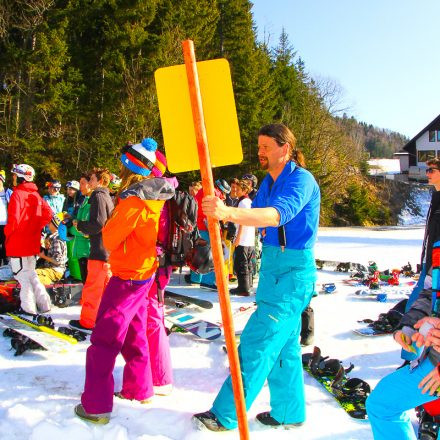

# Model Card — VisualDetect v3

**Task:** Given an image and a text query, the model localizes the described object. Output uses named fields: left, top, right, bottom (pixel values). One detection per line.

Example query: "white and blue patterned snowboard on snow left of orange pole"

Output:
left=165, top=307, right=222, bottom=341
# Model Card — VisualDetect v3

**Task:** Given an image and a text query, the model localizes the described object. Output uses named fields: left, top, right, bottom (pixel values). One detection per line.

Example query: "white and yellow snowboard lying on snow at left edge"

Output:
left=0, top=315, right=76, bottom=354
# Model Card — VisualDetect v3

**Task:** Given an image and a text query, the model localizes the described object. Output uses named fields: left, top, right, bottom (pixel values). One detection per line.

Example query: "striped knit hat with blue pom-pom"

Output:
left=121, top=138, right=166, bottom=177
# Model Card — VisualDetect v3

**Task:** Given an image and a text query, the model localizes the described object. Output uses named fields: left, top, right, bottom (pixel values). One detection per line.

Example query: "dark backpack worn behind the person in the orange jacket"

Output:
left=159, top=191, right=199, bottom=268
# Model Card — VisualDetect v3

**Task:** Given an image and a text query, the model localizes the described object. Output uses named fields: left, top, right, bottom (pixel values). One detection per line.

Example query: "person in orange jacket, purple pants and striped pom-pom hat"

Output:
left=75, top=138, right=174, bottom=424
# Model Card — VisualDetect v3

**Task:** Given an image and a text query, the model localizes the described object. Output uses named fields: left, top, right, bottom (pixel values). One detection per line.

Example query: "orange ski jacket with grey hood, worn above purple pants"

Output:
left=102, top=178, right=174, bottom=280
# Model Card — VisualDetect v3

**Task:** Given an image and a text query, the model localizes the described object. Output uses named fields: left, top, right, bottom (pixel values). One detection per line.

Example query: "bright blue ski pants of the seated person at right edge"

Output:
left=366, top=358, right=438, bottom=440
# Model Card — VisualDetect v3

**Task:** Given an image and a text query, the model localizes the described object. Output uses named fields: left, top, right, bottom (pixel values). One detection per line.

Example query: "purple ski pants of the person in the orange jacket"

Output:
left=81, top=276, right=154, bottom=414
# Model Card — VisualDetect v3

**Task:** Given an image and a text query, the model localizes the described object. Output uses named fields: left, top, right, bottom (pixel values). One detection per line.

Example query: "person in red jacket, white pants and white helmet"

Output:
left=5, top=164, right=53, bottom=314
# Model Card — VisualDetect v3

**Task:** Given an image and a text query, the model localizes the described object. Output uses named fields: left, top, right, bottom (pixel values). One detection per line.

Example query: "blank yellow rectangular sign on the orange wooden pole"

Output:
left=154, top=58, right=243, bottom=173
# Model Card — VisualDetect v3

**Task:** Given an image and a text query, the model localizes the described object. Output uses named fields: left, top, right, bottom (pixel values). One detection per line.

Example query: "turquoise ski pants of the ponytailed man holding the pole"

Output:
left=211, top=246, right=316, bottom=429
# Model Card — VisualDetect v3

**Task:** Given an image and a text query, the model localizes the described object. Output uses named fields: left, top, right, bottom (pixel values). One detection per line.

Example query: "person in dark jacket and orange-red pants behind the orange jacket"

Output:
left=69, top=168, right=113, bottom=333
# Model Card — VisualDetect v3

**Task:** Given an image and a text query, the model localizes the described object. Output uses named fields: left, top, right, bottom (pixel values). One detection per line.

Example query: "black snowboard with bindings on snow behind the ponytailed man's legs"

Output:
left=302, top=347, right=370, bottom=419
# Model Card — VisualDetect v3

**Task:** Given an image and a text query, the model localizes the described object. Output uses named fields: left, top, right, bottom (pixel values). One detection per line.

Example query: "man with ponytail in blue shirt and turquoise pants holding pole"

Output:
left=194, top=124, right=320, bottom=431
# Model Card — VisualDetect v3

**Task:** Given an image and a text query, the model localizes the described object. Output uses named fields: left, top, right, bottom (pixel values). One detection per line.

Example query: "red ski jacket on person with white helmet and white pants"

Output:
left=5, top=182, right=53, bottom=257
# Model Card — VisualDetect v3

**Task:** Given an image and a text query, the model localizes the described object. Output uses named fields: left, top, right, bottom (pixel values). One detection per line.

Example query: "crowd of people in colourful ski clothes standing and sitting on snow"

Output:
left=5, top=124, right=440, bottom=439
